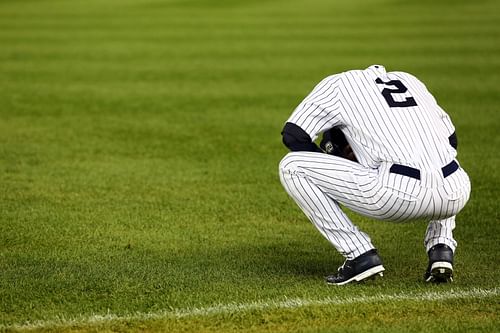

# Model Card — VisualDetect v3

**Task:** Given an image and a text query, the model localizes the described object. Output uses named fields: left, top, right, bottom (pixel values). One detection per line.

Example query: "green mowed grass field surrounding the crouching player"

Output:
left=0, top=0, right=500, bottom=332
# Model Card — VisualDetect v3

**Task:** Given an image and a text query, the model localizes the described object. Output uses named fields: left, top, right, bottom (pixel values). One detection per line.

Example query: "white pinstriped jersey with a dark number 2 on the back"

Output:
left=288, top=65, right=456, bottom=170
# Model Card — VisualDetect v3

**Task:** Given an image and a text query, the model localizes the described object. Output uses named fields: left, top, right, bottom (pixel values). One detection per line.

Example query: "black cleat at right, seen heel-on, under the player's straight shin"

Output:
left=424, top=244, right=453, bottom=283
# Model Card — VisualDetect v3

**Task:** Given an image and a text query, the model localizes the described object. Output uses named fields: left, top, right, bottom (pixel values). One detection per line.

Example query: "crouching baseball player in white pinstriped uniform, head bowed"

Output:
left=279, top=65, right=470, bottom=285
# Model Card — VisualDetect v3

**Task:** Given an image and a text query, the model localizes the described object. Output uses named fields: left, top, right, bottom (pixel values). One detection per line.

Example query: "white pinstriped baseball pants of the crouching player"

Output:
left=279, top=152, right=470, bottom=259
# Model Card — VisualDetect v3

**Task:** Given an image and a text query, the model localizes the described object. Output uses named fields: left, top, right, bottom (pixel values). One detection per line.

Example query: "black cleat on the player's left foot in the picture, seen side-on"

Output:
left=326, top=249, right=385, bottom=286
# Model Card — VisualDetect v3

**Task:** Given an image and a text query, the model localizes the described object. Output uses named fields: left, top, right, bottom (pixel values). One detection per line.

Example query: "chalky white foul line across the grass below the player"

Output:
left=0, top=288, right=500, bottom=330
